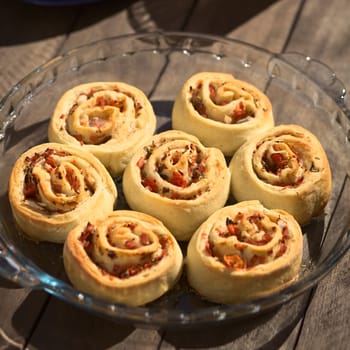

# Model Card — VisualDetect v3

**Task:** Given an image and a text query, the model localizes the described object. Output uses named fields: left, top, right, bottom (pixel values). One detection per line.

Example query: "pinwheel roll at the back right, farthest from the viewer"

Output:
left=172, top=72, right=274, bottom=156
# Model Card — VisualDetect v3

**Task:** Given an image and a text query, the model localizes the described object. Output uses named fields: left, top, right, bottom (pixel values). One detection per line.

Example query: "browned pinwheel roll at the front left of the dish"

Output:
left=63, top=210, right=183, bottom=306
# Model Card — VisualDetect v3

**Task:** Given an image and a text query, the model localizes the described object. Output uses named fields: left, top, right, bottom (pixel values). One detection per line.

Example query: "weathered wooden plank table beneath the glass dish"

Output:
left=0, top=0, right=350, bottom=350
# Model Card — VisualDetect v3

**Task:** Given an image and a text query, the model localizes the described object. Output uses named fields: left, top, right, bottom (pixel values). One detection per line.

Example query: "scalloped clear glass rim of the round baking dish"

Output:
left=0, top=31, right=350, bottom=326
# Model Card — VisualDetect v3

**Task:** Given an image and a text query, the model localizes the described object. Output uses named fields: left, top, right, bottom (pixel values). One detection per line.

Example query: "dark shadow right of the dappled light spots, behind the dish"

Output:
left=128, top=0, right=276, bottom=35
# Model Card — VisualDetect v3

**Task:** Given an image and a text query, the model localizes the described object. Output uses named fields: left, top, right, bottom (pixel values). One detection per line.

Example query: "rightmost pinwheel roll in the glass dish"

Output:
left=229, top=125, right=332, bottom=225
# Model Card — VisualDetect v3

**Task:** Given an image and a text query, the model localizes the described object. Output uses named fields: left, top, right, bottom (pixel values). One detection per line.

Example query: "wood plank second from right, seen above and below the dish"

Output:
left=154, top=1, right=309, bottom=350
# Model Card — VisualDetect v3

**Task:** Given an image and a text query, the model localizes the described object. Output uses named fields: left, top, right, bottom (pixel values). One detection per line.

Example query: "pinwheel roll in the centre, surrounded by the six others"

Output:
left=123, top=130, right=230, bottom=240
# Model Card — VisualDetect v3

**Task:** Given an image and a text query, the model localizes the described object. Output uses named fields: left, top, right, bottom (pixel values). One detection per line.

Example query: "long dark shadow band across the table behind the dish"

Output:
left=0, top=0, right=277, bottom=46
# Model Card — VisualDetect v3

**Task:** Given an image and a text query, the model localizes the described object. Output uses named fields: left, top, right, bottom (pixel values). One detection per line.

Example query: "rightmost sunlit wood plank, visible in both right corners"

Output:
left=286, top=0, right=350, bottom=349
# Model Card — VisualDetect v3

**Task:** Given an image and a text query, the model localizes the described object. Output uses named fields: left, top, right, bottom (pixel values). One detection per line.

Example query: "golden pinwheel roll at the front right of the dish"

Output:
left=186, top=201, right=303, bottom=304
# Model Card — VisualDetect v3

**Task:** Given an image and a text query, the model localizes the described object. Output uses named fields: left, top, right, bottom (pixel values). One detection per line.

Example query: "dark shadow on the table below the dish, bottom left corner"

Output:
left=12, top=291, right=135, bottom=350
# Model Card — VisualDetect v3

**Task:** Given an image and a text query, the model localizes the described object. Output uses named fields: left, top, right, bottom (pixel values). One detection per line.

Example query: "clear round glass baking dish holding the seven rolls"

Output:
left=0, top=33, right=350, bottom=326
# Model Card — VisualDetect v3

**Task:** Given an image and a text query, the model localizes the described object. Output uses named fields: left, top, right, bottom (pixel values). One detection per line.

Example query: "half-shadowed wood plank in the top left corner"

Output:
left=0, top=1, right=79, bottom=97
